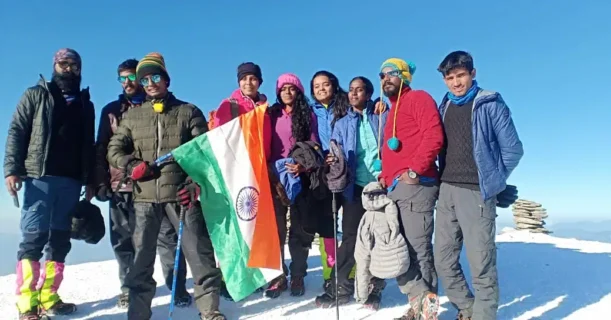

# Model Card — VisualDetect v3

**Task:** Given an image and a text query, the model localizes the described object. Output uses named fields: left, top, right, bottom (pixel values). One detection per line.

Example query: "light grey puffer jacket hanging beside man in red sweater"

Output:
left=354, top=182, right=410, bottom=303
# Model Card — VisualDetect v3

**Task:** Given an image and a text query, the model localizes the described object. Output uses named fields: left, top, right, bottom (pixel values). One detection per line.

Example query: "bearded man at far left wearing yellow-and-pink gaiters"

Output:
left=4, top=49, right=95, bottom=320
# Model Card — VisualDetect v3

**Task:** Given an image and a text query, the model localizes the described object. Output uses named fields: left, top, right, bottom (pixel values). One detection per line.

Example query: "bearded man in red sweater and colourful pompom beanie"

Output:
left=380, top=58, right=443, bottom=320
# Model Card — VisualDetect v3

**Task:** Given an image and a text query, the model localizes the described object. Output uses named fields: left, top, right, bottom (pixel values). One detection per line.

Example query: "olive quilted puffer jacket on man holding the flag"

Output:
left=107, top=93, right=208, bottom=203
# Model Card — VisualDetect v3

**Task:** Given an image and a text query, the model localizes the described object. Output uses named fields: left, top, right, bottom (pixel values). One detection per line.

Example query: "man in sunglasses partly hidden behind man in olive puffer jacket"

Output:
left=95, top=59, right=191, bottom=308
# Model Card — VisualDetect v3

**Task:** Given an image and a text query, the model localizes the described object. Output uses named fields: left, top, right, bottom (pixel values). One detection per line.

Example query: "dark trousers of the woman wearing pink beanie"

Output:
left=274, top=197, right=314, bottom=277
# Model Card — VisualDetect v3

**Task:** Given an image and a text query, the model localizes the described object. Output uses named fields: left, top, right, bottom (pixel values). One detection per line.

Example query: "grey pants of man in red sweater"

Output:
left=388, top=183, right=439, bottom=298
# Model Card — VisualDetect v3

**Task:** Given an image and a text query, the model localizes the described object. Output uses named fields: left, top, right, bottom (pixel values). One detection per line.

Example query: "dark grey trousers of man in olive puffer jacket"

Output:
left=125, top=202, right=221, bottom=320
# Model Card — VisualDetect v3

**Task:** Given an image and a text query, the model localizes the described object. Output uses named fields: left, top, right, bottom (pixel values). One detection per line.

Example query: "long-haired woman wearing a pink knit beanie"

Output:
left=265, top=73, right=320, bottom=298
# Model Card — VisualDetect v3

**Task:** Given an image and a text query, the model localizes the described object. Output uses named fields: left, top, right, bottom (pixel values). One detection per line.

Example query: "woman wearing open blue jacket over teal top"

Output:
left=316, top=77, right=388, bottom=309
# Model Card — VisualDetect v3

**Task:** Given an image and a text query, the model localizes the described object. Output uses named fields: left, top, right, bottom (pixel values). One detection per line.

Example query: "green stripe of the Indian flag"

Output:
left=172, top=134, right=267, bottom=301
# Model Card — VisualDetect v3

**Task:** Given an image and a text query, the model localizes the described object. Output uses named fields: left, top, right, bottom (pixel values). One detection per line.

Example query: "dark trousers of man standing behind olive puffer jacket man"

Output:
left=108, top=192, right=187, bottom=294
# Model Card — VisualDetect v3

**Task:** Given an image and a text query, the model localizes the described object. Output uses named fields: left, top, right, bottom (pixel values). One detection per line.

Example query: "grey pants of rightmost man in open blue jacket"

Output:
left=435, top=183, right=499, bottom=320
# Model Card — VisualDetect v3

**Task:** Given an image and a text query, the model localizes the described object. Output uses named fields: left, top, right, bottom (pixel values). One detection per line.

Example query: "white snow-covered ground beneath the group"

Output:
left=0, top=229, right=611, bottom=320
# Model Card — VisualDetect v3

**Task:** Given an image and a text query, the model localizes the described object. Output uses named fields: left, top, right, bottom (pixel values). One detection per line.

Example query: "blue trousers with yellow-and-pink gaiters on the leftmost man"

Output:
left=16, top=176, right=81, bottom=313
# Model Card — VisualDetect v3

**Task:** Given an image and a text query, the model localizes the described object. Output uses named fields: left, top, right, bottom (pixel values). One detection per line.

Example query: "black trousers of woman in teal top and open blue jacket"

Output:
left=329, top=185, right=365, bottom=295
